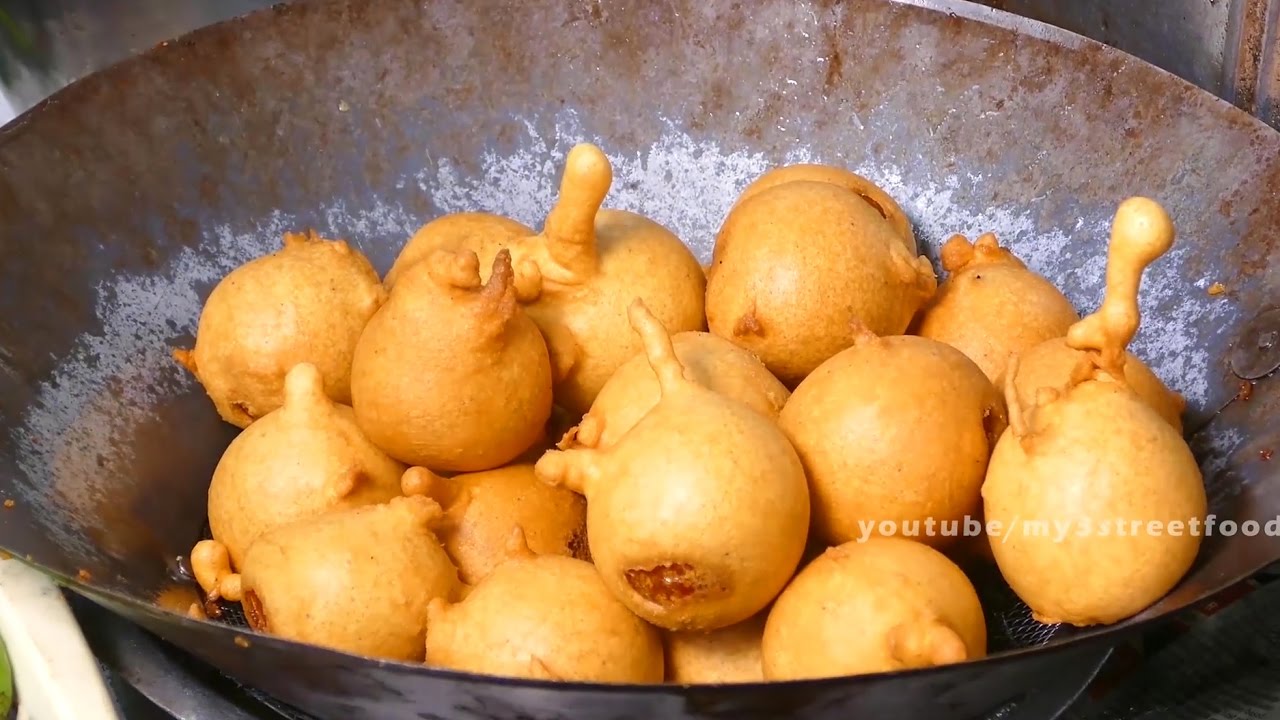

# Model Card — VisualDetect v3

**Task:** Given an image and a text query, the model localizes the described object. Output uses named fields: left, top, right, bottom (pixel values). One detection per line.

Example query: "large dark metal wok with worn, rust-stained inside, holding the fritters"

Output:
left=0, top=0, right=1280, bottom=720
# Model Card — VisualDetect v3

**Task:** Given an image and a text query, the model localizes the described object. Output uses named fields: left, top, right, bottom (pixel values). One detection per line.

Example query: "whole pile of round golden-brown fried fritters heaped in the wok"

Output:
left=174, top=145, right=1206, bottom=683
